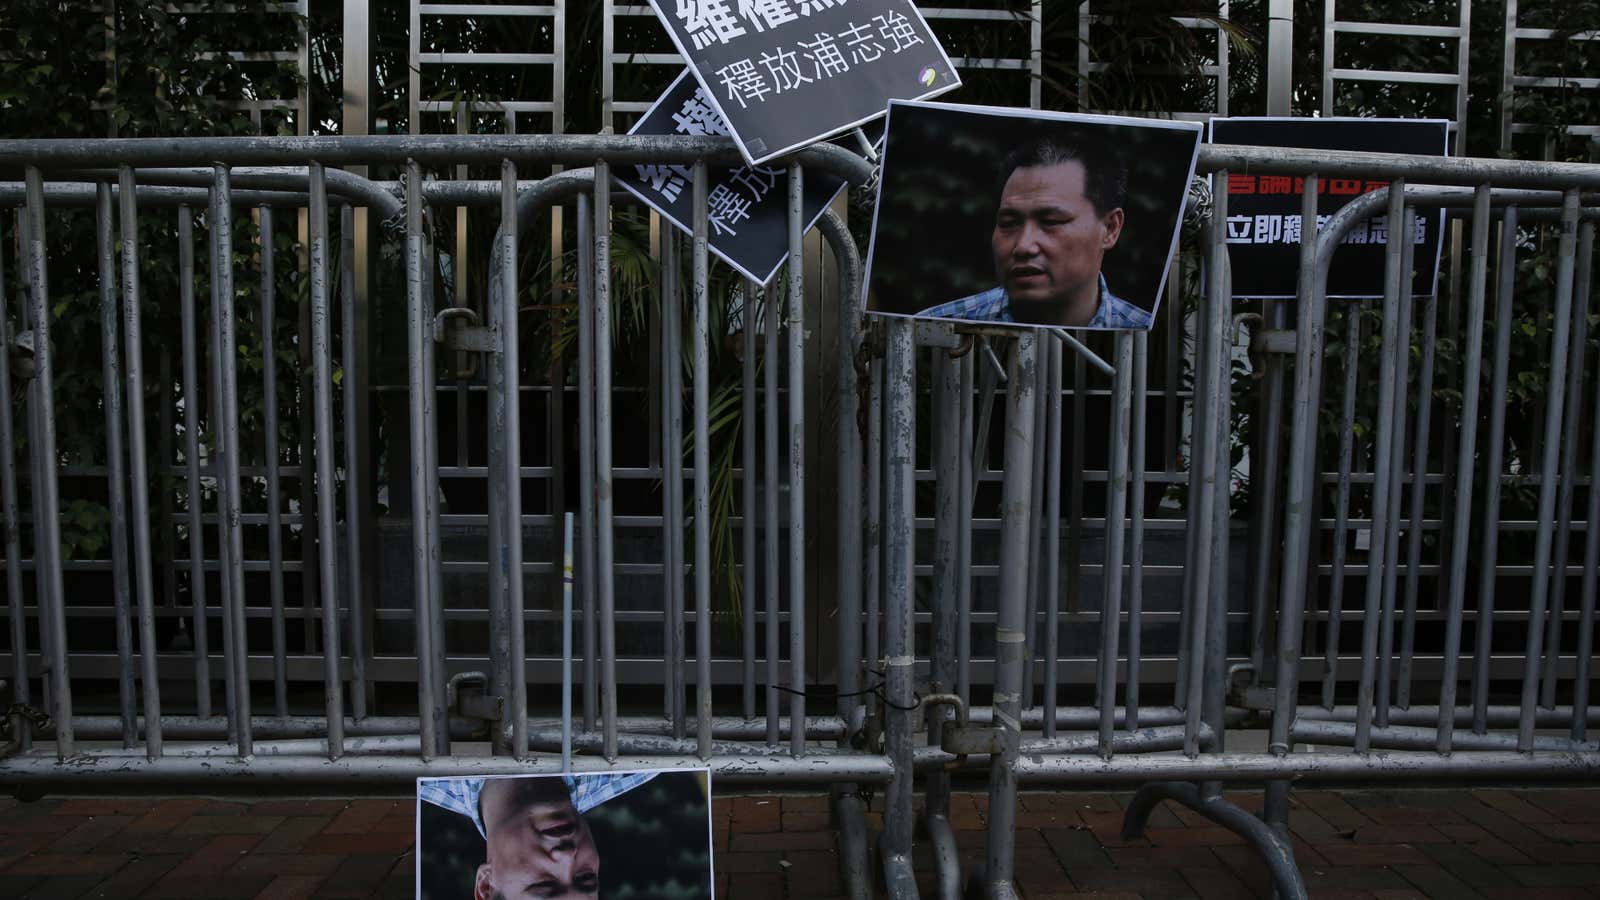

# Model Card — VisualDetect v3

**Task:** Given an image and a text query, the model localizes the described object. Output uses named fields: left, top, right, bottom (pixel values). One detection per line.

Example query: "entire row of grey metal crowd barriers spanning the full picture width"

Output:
left=0, top=136, right=1600, bottom=897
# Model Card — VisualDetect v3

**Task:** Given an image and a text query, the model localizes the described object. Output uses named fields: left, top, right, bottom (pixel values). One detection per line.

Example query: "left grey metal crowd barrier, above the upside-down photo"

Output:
left=0, top=136, right=915, bottom=897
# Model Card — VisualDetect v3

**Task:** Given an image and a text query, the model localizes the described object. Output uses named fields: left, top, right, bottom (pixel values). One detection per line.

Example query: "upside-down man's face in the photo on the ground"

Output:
left=472, top=778, right=600, bottom=900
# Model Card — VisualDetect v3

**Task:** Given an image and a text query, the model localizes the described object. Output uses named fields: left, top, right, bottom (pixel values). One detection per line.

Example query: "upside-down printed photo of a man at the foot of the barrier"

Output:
left=416, top=769, right=714, bottom=900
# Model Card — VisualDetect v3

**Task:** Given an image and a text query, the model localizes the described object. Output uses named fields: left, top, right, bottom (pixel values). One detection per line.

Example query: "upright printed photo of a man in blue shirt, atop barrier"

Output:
left=866, top=102, right=1202, bottom=330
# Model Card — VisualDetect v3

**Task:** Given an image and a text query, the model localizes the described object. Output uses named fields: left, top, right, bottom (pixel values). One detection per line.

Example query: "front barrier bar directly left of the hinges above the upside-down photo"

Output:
left=405, top=160, right=440, bottom=759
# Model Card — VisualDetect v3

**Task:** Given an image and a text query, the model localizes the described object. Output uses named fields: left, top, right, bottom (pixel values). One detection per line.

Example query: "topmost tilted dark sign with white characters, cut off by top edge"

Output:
left=650, top=0, right=962, bottom=163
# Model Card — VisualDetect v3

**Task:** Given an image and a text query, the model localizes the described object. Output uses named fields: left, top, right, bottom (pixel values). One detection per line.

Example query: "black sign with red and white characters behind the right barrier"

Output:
left=1211, top=119, right=1450, bottom=298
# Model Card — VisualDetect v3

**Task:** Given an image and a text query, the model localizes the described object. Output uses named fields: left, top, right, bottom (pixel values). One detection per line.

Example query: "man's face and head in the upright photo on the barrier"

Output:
left=992, top=160, right=1123, bottom=325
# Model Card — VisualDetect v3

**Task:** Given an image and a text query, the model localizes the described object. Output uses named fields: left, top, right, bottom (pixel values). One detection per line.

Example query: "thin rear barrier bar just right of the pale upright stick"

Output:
left=578, top=194, right=600, bottom=732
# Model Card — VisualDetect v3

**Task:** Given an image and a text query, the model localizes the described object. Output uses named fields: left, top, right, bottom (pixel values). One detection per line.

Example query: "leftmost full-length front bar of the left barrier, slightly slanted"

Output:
left=24, top=167, right=75, bottom=759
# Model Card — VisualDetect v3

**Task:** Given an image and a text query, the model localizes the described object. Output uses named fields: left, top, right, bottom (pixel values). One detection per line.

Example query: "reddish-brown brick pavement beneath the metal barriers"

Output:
left=0, top=788, right=1600, bottom=900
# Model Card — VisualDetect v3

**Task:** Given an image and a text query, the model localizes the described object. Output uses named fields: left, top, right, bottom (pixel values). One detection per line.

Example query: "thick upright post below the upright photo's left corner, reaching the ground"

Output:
left=883, top=315, right=917, bottom=890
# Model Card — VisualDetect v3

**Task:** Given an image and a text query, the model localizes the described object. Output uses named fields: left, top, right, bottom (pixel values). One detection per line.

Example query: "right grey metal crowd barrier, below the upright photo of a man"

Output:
left=902, top=146, right=1600, bottom=898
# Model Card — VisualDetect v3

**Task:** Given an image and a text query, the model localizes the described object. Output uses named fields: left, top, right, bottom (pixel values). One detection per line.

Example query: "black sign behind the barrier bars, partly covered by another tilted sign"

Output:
left=613, top=70, right=845, bottom=285
